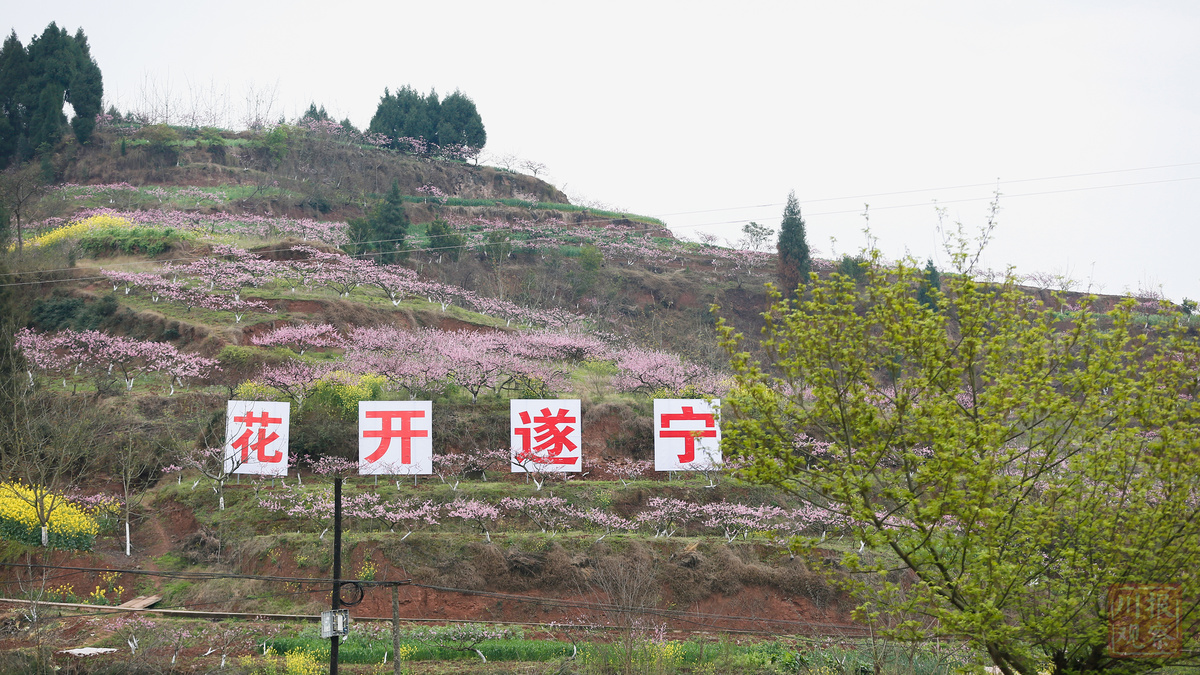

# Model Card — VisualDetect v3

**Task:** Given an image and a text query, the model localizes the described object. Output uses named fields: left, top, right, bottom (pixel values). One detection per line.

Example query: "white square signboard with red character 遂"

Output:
left=509, top=399, right=583, bottom=473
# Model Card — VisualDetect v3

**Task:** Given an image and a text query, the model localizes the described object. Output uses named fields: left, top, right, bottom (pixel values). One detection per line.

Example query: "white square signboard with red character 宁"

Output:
left=654, top=399, right=721, bottom=471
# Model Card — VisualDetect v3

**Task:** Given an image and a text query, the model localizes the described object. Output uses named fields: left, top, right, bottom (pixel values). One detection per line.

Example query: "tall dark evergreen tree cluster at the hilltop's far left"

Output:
left=0, top=23, right=104, bottom=166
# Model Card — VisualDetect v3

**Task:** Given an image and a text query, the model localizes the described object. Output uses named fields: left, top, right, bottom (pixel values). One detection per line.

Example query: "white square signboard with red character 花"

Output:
left=224, top=401, right=292, bottom=476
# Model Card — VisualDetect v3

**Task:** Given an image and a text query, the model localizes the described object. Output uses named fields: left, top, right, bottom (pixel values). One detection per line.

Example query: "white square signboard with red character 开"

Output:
left=359, top=401, right=433, bottom=476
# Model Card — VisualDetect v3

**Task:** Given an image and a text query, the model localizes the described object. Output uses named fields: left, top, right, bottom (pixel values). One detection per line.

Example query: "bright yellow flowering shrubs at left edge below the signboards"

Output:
left=0, top=483, right=100, bottom=550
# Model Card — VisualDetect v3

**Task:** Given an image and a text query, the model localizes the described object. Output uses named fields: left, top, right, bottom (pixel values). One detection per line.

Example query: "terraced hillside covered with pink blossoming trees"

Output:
left=0, top=127, right=1194, bottom=673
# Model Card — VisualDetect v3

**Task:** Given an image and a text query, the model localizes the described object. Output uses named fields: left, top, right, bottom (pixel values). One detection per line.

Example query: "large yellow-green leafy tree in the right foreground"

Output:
left=720, top=246, right=1200, bottom=675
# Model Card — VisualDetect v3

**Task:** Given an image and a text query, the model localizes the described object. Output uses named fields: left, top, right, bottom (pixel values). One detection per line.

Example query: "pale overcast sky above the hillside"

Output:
left=4, top=0, right=1200, bottom=301
